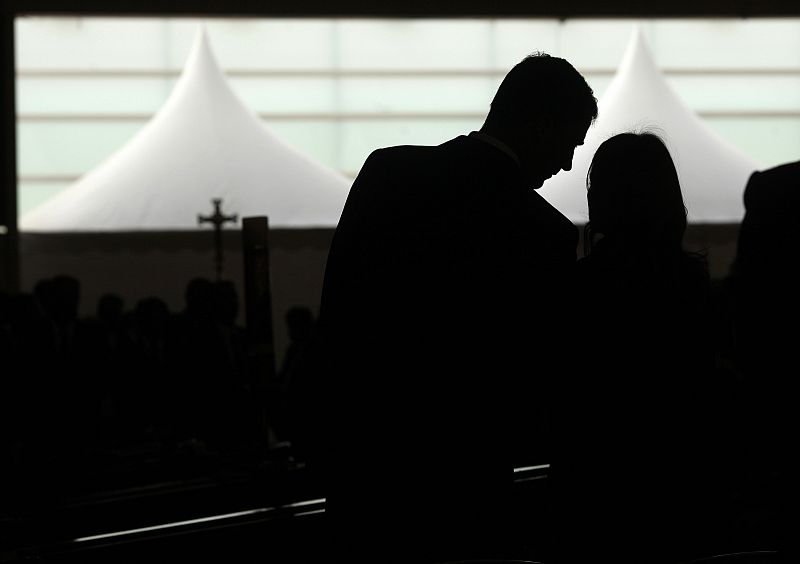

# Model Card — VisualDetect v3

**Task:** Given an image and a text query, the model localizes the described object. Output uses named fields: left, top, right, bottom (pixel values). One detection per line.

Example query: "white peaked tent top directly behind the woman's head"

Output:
left=540, top=27, right=759, bottom=224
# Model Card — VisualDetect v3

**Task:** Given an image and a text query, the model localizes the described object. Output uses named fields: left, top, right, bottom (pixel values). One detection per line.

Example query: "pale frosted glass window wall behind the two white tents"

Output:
left=16, top=17, right=800, bottom=217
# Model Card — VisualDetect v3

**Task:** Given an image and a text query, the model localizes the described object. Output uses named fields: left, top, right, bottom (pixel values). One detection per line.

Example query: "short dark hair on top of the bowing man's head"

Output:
left=487, top=52, right=597, bottom=126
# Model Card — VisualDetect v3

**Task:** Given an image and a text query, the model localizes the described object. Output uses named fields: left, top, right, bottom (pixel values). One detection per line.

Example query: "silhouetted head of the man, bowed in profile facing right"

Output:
left=481, top=53, right=597, bottom=188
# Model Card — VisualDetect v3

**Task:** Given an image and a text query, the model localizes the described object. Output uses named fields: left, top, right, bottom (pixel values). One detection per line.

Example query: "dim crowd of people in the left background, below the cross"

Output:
left=0, top=275, right=269, bottom=503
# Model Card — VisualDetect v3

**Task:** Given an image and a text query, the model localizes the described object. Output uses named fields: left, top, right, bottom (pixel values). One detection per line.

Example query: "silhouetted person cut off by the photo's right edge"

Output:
left=729, top=161, right=800, bottom=561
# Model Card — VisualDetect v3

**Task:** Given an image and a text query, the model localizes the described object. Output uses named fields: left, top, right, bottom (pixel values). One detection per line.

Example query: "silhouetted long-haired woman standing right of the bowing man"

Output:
left=552, top=133, right=714, bottom=562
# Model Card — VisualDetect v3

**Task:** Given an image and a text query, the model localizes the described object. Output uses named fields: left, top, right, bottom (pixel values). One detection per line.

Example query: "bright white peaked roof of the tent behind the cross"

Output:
left=20, top=29, right=350, bottom=232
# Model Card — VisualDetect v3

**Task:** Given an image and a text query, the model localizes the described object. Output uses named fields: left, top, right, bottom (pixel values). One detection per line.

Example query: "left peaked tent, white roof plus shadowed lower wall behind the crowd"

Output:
left=20, top=30, right=350, bottom=358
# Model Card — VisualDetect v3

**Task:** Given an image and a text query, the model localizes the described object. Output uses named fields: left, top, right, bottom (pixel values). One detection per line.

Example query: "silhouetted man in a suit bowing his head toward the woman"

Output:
left=320, top=54, right=597, bottom=562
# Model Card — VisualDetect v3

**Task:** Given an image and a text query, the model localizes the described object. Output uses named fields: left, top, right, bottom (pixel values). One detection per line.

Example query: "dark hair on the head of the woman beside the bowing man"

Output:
left=585, top=132, right=687, bottom=254
